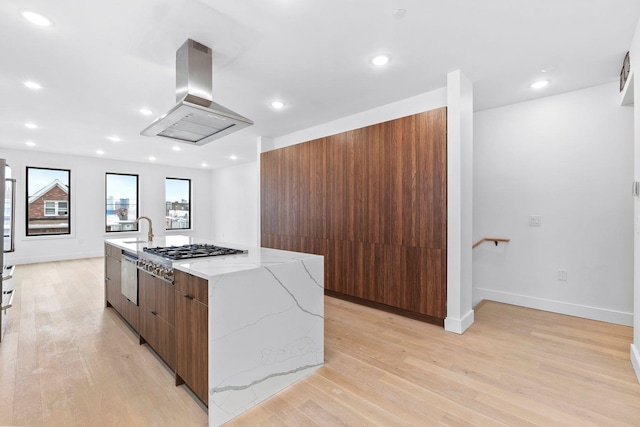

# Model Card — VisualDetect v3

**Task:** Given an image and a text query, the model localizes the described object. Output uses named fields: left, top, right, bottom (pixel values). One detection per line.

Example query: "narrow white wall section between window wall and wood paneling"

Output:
left=210, top=162, right=260, bottom=246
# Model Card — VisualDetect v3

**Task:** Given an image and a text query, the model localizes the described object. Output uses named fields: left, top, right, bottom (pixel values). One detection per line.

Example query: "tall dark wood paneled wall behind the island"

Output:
left=261, top=108, right=447, bottom=321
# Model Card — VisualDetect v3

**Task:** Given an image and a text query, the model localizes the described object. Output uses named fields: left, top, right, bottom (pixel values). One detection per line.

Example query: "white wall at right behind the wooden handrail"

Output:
left=473, top=83, right=633, bottom=325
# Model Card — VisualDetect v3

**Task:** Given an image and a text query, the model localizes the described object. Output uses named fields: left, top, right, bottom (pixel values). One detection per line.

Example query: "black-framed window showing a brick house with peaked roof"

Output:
left=26, top=167, right=71, bottom=236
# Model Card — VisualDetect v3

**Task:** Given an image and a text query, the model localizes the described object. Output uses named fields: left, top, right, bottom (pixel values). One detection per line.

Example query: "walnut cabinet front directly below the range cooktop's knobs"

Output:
left=138, top=271, right=176, bottom=371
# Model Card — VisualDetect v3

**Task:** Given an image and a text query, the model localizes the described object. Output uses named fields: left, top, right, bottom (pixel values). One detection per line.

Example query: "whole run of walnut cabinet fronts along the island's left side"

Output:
left=105, top=244, right=209, bottom=405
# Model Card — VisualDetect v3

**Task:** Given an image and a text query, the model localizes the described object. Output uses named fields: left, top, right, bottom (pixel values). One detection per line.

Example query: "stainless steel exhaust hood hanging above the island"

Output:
left=140, top=39, right=253, bottom=145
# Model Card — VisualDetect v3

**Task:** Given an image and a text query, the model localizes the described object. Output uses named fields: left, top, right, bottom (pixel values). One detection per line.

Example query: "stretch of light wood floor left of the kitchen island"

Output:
left=0, top=258, right=208, bottom=426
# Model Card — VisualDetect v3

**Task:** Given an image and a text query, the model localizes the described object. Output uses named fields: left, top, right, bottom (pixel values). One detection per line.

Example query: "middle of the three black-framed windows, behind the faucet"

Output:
left=105, top=172, right=138, bottom=232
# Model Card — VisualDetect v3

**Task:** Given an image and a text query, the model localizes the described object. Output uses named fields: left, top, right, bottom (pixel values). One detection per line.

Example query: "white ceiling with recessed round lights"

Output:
left=0, top=0, right=640, bottom=168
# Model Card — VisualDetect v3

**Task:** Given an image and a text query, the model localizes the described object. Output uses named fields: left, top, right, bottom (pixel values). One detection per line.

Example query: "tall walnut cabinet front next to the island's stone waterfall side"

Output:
left=175, top=271, right=209, bottom=405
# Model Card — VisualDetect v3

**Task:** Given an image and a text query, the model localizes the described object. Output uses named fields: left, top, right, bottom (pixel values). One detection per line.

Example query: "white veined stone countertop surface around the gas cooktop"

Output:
left=105, top=235, right=322, bottom=280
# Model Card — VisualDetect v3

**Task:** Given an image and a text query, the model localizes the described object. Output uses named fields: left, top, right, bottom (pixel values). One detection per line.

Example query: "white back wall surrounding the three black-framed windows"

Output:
left=0, top=149, right=211, bottom=264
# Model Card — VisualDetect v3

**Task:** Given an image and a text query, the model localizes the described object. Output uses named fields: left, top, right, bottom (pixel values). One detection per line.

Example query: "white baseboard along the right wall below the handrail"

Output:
left=474, top=288, right=633, bottom=326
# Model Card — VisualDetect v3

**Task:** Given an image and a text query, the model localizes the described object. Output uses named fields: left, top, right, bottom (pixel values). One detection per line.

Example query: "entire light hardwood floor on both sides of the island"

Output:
left=0, top=258, right=640, bottom=426
